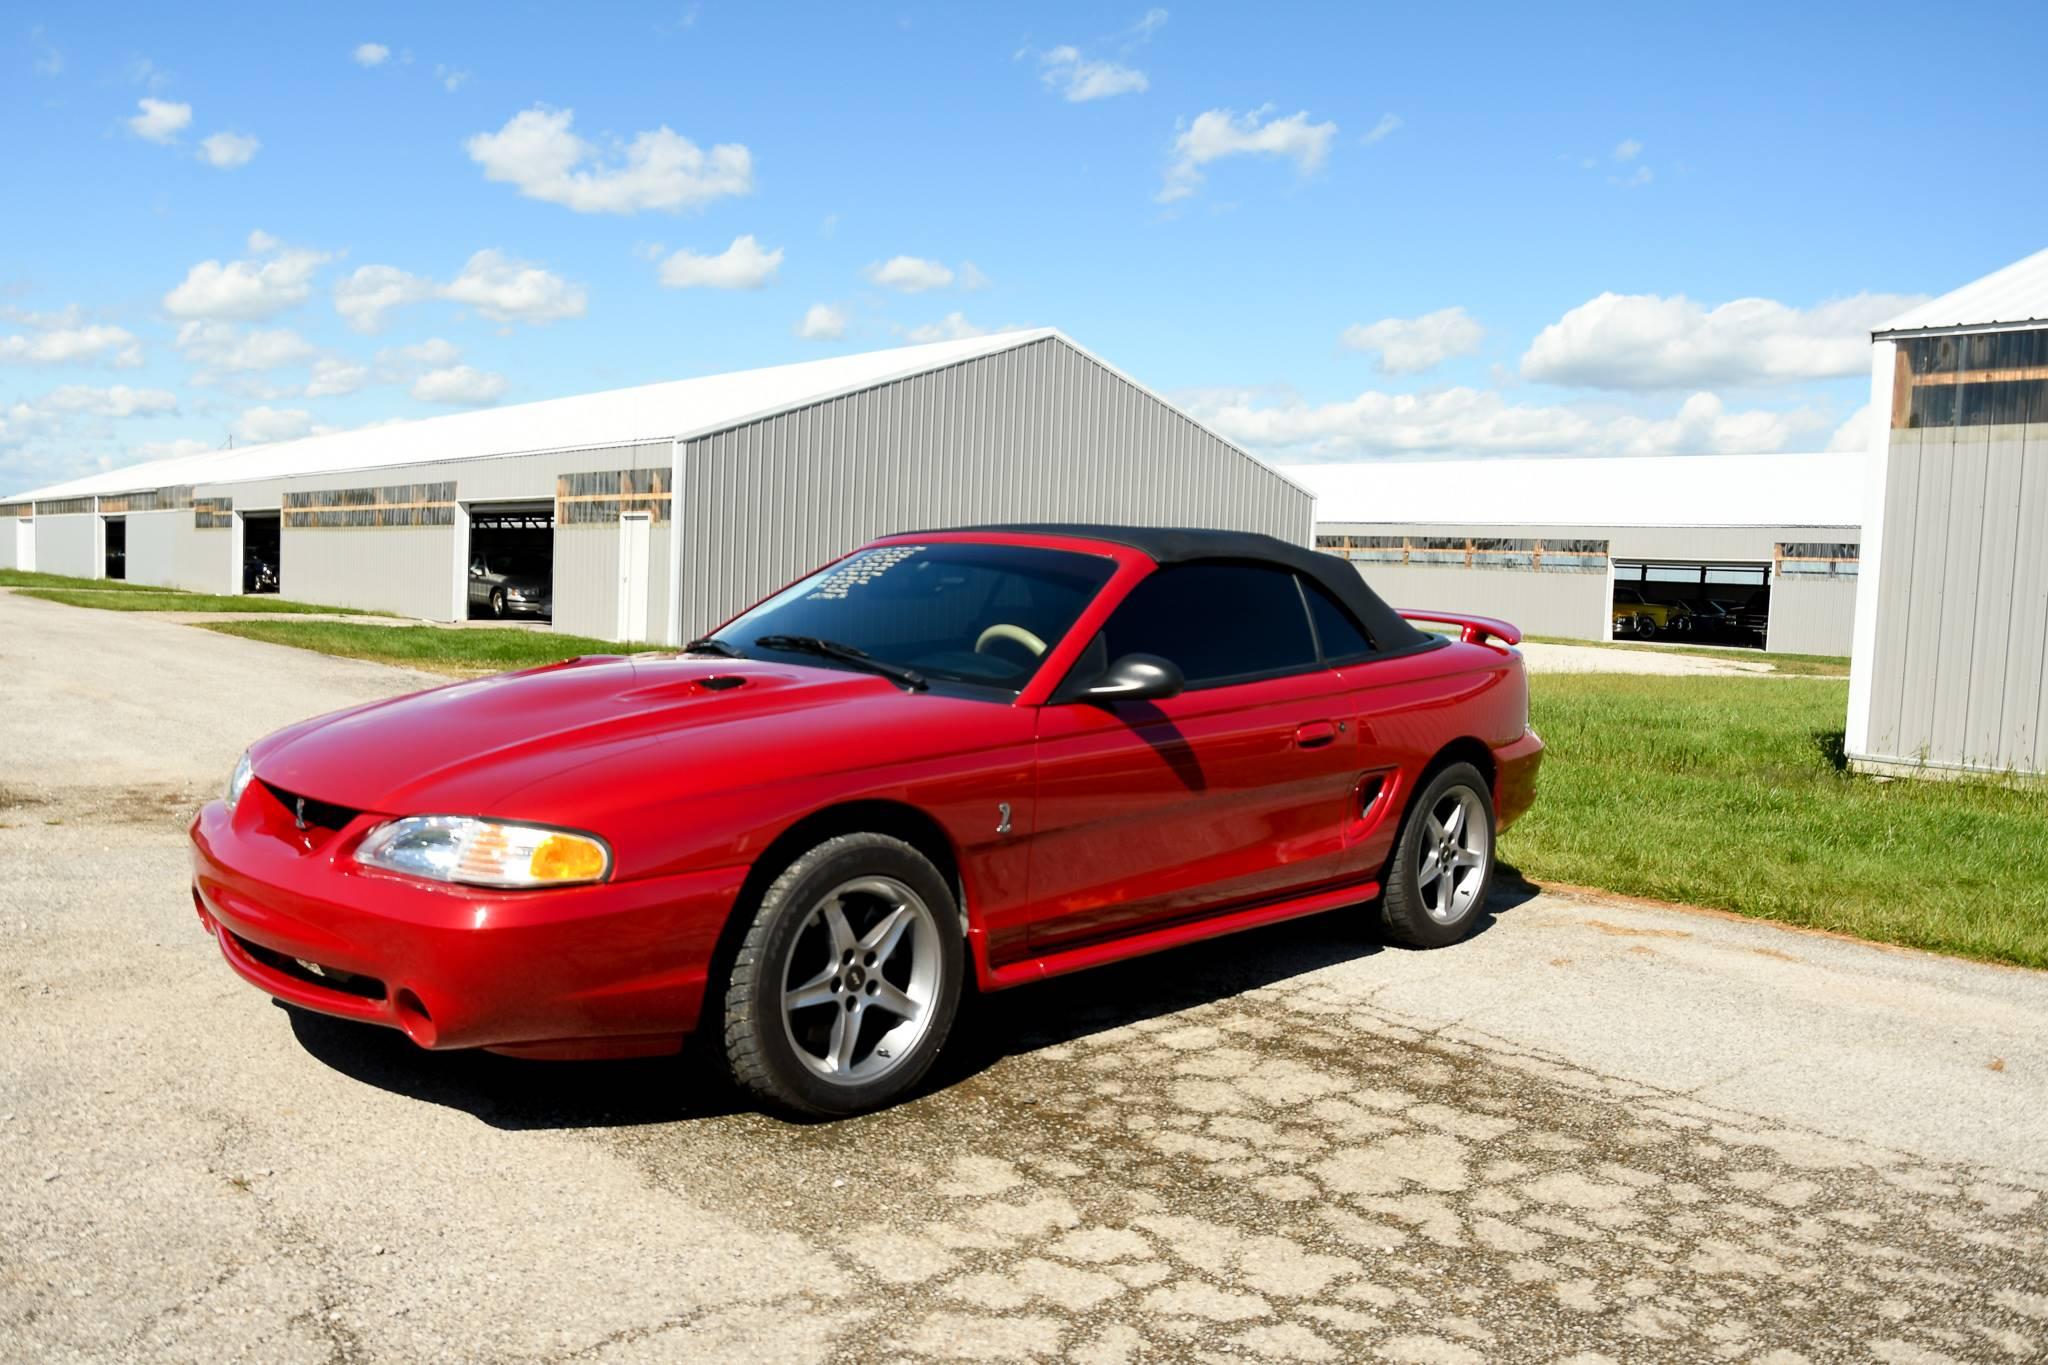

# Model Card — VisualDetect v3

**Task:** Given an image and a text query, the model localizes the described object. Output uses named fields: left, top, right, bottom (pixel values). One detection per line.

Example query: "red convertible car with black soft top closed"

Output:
left=193, top=526, right=1542, bottom=1115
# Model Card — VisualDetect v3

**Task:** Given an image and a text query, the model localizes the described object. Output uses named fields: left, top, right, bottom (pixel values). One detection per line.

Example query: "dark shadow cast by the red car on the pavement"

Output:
left=276, top=864, right=1538, bottom=1130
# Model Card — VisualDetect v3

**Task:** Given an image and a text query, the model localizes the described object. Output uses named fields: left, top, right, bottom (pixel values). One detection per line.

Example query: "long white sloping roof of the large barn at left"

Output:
left=16, top=327, right=1073, bottom=499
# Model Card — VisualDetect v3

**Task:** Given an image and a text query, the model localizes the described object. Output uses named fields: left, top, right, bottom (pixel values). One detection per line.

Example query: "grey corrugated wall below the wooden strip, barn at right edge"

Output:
left=1860, top=422, right=2048, bottom=772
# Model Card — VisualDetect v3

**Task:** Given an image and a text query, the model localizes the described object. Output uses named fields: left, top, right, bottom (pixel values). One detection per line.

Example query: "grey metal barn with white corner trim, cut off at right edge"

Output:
left=1843, top=252, right=2048, bottom=776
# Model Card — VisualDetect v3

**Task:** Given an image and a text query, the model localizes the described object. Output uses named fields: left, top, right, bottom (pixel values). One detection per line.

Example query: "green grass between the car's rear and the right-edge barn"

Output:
left=1501, top=673, right=2048, bottom=968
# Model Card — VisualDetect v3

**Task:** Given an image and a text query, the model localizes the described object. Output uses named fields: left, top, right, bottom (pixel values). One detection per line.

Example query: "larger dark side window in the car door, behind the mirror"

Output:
left=1090, top=563, right=1315, bottom=688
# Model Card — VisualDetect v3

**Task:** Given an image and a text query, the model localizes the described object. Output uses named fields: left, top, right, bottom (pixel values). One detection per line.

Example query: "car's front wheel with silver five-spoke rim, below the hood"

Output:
left=725, top=835, right=965, bottom=1117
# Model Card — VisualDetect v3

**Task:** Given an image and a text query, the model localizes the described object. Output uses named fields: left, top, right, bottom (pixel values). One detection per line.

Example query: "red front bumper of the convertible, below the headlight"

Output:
left=190, top=782, right=745, bottom=1056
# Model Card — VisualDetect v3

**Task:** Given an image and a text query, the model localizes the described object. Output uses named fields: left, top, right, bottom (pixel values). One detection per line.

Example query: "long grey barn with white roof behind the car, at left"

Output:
left=8, top=329, right=1311, bottom=643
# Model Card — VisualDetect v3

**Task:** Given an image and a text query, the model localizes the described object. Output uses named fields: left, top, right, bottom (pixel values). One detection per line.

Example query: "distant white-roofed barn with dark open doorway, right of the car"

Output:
left=1286, top=454, right=1864, bottom=655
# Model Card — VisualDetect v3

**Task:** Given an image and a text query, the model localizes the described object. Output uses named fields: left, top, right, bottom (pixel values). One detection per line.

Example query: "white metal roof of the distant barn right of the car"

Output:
left=1280, top=452, right=1866, bottom=526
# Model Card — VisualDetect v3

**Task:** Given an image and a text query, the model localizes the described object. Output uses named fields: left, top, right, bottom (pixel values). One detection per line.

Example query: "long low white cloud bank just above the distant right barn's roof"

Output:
left=1184, top=387, right=1825, bottom=460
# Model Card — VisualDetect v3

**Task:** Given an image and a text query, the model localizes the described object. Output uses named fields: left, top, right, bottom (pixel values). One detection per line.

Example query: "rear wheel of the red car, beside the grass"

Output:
left=1380, top=763, right=1493, bottom=948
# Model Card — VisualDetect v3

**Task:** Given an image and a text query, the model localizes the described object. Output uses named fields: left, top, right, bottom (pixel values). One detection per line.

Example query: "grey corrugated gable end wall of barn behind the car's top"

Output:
left=680, top=338, right=1311, bottom=634
